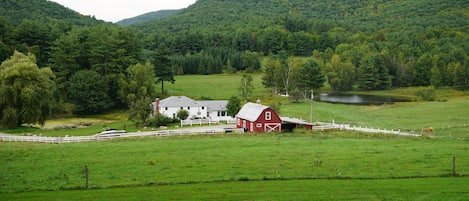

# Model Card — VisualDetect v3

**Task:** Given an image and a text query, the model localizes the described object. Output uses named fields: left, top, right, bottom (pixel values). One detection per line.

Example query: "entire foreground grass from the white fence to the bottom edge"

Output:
left=0, top=132, right=469, bottom=200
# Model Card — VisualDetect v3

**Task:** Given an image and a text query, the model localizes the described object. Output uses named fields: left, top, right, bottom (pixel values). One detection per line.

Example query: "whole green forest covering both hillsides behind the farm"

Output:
left=0, top=0, right=469, bottom=127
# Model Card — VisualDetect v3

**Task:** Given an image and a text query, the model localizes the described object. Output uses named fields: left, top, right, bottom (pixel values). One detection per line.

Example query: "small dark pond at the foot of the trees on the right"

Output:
left=315, top=93, right=409, bottom=105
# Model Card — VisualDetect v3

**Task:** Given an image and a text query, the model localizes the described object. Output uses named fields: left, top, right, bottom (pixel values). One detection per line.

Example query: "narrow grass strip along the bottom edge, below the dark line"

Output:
left=0, top=177, right=469, bottom=201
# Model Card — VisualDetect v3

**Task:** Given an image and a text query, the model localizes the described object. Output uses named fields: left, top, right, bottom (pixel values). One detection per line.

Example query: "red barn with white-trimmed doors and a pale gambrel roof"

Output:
left=236, top=103, right=282, bottom=133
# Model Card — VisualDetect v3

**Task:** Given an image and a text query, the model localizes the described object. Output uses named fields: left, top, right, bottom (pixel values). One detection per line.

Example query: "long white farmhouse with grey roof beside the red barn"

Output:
left=152, top=96, right=233, bottom=121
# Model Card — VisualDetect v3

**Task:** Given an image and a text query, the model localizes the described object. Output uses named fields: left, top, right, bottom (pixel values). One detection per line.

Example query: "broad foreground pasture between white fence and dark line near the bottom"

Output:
left=0, top=132, right=469, bottom=193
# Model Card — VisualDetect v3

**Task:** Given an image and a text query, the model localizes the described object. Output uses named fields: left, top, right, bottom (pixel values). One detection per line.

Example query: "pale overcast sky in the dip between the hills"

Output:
left=51, top=0, right=196, bottom=22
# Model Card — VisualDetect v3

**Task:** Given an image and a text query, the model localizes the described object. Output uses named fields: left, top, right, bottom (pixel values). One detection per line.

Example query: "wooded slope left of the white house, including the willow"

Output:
left=0, top=0, right=144, bottom=128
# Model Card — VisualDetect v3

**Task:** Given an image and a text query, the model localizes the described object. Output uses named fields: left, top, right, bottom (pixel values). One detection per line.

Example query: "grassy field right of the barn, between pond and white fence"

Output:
left=280, top=100, right=469, bottom=138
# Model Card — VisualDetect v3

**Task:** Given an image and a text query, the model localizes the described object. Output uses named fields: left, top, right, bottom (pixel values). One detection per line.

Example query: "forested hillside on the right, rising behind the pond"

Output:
left=135, top=0, right=469, bottom=90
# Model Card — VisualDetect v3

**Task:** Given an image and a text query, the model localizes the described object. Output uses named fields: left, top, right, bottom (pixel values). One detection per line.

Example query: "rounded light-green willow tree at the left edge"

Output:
left=0, top=52, right=55, bottom=128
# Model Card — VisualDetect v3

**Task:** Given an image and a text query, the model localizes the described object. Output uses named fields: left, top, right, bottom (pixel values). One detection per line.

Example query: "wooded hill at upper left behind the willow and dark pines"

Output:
left=0, top=0, right=106, bottom=66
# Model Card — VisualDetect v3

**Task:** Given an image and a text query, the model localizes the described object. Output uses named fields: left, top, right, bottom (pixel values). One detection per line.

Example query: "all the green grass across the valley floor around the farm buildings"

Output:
left=0, top=75, right=469, bottom=200
